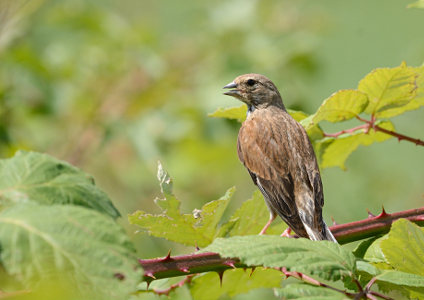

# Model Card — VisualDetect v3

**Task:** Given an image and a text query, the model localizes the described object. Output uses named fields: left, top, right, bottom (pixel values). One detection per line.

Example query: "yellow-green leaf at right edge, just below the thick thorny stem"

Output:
left=381, top=219, right=424, bottom=276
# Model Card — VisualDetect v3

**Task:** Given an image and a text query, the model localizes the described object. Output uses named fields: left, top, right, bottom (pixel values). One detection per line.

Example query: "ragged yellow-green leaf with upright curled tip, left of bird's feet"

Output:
left=128, top=162, right=284, bottom=247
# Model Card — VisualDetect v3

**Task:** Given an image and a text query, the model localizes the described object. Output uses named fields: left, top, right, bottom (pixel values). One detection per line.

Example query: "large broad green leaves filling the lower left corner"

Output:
left=0, top=152, right=141, bottom=299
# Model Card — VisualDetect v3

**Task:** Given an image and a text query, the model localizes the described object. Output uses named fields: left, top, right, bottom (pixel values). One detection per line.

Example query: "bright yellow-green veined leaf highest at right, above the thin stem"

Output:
left=358, top=64, right=418, bottom=118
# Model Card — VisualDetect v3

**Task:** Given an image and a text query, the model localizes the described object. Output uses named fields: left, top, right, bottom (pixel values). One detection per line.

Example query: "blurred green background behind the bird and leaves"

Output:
left=0, top=0, right=424, bottom=257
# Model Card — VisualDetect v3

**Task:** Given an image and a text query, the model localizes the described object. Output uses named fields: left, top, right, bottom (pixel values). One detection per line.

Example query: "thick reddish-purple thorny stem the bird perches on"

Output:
left=139, top=207, right=424, bottom=282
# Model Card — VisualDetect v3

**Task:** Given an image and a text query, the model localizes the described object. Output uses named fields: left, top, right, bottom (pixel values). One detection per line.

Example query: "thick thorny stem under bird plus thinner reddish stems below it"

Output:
left=139, top=207, right=424, bottom=300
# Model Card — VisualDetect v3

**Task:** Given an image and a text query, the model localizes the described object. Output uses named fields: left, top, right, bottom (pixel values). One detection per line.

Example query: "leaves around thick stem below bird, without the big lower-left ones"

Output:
left=129, top=163, right=424, bottom=299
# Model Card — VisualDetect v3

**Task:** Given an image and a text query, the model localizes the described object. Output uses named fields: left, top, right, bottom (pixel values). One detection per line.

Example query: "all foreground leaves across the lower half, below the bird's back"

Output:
left=0, top=152, right=424, bottom=299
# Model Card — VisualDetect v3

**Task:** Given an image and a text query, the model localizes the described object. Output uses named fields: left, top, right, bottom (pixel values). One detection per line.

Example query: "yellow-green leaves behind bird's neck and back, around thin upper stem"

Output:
left=209, top=63, right=424, bottom=169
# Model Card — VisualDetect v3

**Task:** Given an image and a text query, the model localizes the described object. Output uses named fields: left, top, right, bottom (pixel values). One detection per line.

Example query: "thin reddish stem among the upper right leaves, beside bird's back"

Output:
left=324, top=115, right=424, bottom=146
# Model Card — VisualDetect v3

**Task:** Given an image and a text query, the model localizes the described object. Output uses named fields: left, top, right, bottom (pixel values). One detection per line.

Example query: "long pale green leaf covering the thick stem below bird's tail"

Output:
left=204, top=235, right=356, bottom=280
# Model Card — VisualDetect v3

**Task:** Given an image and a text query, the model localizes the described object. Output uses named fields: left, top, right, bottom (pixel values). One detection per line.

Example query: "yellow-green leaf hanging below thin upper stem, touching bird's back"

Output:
left=315, top=121, right=394, bottom=170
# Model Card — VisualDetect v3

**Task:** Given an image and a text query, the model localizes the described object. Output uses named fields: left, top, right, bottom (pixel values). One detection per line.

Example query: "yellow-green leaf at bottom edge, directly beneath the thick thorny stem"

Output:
left=190, top=268, right=282, bottom=300
